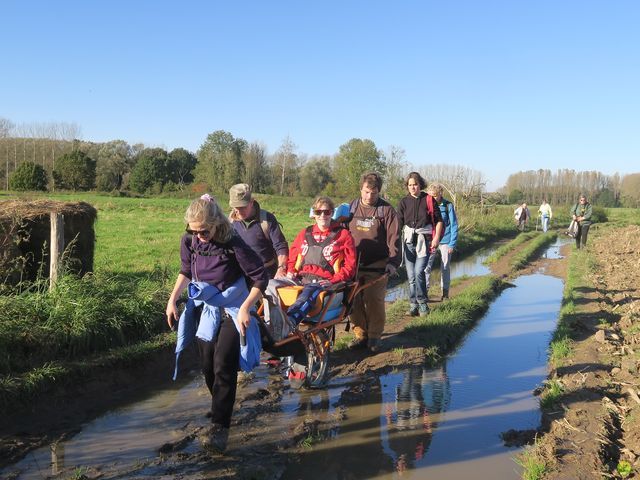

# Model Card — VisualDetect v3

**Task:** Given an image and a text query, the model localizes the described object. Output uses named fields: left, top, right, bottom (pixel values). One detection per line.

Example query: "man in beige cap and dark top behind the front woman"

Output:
left=229, top=183, right=289, bottom=278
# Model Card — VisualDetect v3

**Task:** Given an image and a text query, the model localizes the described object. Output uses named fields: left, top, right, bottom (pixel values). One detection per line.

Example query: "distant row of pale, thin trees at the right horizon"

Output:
left=503, top=169, right=640, bottom=207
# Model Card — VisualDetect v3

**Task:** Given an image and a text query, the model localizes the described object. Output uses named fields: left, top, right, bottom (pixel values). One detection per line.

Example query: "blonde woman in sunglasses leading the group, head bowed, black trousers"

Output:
left=166, top=194, right=269, bottom=451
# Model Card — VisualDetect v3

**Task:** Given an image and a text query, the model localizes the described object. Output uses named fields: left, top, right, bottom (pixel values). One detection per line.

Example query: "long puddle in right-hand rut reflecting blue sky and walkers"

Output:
left=285, top=275, right=562, bottom=480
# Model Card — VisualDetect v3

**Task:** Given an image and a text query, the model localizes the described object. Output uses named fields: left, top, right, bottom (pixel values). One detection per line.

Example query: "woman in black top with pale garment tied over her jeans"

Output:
left=398, top=172, right=442, bottom=317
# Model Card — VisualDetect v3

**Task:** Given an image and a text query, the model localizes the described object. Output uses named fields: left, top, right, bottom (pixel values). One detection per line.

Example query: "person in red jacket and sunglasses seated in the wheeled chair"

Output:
left=287, top=197, right=356, bottom=323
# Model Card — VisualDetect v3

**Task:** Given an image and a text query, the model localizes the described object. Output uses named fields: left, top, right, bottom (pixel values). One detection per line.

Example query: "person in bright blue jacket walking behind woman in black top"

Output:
left=425, top=183, right=458, bottom=300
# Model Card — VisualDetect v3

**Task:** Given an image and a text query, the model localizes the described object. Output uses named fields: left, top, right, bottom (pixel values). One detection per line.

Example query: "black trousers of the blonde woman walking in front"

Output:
left=197, top=315, right=240, bottom=428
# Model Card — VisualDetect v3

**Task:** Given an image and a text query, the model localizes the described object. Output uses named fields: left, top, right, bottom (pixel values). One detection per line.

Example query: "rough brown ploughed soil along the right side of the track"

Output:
left=538, top=226, right=640, bottom=479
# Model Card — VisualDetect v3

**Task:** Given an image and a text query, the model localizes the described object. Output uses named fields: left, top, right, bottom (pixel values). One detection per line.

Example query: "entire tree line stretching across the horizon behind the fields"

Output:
left=0, top=117, right=640, bottom=206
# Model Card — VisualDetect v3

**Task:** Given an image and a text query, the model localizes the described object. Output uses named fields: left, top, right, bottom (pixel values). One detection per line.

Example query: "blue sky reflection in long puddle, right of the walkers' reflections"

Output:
left=412, top=275, right=562, bottom=478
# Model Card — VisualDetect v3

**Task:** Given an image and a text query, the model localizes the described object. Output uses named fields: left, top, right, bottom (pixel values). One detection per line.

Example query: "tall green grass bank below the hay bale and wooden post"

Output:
left=0, top=273, right=166, bottom=408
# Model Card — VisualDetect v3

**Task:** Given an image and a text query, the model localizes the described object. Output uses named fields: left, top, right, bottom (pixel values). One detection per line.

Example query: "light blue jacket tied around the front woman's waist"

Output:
left=173, top=277, right=262, bottom=380
